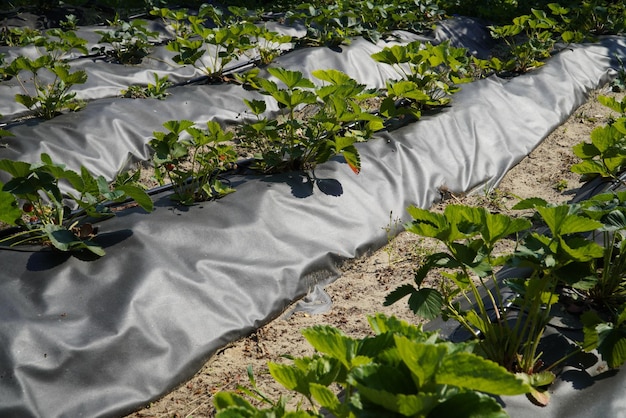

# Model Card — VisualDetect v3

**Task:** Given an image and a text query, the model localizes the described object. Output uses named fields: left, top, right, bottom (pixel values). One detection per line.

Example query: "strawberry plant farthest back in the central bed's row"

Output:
left=372, top=41, right=471, bottom=119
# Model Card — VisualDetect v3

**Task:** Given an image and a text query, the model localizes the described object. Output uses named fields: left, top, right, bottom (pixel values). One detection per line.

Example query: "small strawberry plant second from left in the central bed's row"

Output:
left=150, top=120, right=237, bottom=205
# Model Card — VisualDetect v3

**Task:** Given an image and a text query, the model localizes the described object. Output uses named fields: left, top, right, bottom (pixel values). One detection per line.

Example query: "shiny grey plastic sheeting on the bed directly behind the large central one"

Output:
left=0, top=18, right=484, bottom=180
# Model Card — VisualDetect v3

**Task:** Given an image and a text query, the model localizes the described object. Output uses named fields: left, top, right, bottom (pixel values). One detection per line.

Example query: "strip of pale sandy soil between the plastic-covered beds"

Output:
left=129, top=86, right=623, bottom=418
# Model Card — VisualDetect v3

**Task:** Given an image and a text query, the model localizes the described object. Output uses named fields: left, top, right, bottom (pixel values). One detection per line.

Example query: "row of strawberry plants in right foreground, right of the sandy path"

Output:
left=214, top=97, right=626, bottom=417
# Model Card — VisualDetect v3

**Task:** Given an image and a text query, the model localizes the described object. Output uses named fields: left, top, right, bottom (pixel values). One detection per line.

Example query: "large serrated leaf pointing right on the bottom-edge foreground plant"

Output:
left=435, top=352, right=530, bottom=395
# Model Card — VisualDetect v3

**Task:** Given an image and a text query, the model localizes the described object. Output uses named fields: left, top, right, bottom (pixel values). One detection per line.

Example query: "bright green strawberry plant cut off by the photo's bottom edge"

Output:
left=214, top=314, right=530, bottom=418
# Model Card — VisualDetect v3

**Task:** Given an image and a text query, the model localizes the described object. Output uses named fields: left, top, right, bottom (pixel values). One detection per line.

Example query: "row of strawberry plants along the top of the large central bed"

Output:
left=0, top=37, right=464, bottom=255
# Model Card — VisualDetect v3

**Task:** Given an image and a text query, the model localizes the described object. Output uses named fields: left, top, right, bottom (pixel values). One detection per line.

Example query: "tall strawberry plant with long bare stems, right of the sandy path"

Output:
left=385, top=205, right=603, bottom=404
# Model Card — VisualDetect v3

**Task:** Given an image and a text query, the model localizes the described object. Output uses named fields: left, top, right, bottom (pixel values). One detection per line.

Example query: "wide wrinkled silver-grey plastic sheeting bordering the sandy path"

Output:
left=0, top=22, right=626, bottom=417
